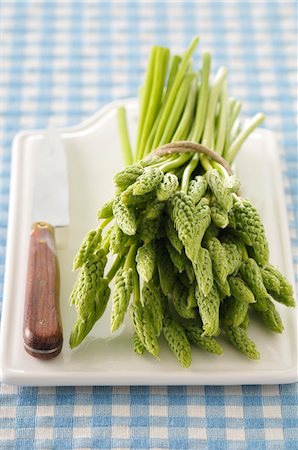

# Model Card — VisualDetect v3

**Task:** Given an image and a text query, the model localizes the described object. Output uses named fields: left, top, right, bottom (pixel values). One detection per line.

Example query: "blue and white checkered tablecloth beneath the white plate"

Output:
left=0, top=0, right=298, bottom=450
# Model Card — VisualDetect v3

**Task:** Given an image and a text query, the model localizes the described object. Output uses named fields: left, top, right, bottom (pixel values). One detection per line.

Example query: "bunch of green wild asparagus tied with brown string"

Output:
left=70, top=38, right=295, bottom=367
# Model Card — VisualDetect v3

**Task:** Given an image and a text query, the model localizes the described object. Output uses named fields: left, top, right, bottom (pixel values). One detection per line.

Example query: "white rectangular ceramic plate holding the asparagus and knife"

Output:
left=0, top=100, right=298, bottom=386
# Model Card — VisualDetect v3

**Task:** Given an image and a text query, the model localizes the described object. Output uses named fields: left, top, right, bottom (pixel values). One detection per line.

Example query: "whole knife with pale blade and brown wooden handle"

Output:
left=23, top=122, right=69, bottom=359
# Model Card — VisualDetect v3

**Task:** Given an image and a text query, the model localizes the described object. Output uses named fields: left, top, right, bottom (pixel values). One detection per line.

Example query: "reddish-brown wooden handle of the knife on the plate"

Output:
left=23, top=222, right=63, bottom=359
